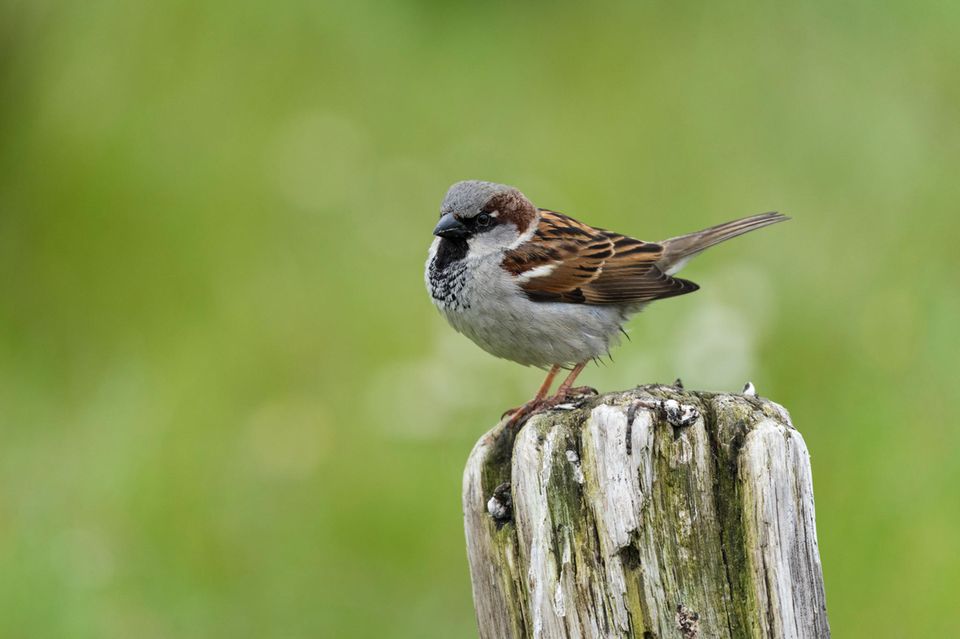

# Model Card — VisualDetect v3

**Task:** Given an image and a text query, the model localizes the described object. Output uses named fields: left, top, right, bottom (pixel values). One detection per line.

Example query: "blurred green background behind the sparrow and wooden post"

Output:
left=0, top=0, right=960, bottom=638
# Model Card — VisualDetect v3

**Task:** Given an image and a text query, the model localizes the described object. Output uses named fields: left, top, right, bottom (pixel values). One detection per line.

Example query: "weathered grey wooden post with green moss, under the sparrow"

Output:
left=463, top=386, right=830, bottom=639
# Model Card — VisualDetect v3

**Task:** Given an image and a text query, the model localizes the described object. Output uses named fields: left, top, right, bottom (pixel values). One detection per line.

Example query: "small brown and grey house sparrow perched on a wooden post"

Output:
left=425, top=180, right=789, bottom=420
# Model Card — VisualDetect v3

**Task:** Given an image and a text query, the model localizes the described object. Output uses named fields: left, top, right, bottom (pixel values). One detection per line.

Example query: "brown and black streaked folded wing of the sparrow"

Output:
left=503, top=209, right=699, bottom=304
